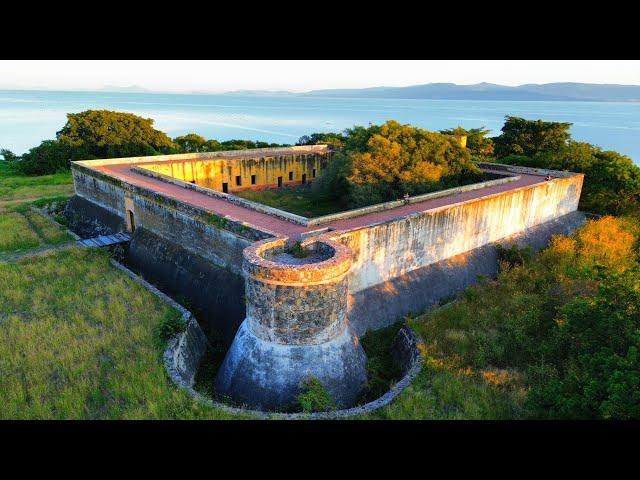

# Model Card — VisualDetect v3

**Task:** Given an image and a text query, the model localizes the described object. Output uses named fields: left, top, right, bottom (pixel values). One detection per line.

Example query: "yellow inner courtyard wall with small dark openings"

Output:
left=141, top=154, right=326, bottom=192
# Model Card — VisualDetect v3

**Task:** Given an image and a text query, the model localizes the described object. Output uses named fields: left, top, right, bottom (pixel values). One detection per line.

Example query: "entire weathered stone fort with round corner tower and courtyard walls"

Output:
left=67, top=145, right=584, bottom=409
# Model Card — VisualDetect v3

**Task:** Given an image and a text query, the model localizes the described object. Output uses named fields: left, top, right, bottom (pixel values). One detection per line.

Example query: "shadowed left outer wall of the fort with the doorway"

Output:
left=67, top=161, right=273, bottom=343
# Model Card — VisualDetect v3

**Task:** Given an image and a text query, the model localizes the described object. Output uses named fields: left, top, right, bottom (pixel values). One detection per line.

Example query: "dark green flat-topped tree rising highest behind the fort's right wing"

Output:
left=493, top=116, right=572, bottom=158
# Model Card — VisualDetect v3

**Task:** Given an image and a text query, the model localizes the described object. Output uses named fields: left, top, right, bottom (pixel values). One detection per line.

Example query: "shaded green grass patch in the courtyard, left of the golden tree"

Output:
left=234, top=185, right=344, bottom=218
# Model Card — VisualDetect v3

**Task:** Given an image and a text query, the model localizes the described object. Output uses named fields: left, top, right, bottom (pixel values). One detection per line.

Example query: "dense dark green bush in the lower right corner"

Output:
left=528, top=267, right=640, bottom=419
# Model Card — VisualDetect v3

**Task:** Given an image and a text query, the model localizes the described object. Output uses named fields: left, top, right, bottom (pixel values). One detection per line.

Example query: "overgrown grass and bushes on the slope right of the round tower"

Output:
left=364, top=216, right=640, bottom=419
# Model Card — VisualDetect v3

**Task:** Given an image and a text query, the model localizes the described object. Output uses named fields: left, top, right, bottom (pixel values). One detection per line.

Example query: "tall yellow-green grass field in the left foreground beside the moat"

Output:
left=0, top=249, right=244, bottom=419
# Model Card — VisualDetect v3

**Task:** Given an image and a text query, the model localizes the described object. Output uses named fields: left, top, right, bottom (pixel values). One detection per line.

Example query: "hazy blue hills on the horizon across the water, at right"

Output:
left=302, top=83, right=640, bottom=102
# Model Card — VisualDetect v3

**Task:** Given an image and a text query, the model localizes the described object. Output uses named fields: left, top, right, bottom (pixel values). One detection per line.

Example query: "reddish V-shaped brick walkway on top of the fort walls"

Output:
left=96, top=165, right=545, bottom=236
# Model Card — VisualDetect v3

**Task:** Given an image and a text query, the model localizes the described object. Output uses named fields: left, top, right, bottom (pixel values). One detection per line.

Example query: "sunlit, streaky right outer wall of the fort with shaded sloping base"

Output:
left=328, top=167, right=585, bottom=335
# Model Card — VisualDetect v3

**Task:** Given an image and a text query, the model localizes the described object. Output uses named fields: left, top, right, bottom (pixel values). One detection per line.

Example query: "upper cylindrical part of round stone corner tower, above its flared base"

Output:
left=243, top=237, right=351, bottom=345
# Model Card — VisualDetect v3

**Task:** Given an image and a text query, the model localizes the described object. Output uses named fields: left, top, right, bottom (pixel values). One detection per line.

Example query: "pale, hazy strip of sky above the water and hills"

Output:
left=0, top=60, right=640, bottom=93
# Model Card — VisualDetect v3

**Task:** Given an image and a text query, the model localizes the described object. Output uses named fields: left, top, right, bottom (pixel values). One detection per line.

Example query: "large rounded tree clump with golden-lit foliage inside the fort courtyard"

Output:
left=301, top=120, right=482, bottom=208
